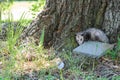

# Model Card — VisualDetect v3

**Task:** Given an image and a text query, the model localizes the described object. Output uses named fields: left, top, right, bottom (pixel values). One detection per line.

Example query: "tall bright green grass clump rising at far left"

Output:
left=7, top=13, right=25, bottom=55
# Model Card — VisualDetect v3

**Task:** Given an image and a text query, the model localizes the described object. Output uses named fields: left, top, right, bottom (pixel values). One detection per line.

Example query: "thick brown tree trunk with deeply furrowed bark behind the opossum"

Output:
left=21, top=0, right=120, bottom=49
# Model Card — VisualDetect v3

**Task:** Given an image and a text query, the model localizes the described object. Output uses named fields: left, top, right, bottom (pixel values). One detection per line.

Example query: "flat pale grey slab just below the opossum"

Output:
left=73, top=41, right=114, bottom=58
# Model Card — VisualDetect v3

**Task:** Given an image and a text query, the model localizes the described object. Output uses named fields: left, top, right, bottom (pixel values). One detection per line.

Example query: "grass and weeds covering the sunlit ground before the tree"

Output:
left=0, top=0, right=120, bottom=80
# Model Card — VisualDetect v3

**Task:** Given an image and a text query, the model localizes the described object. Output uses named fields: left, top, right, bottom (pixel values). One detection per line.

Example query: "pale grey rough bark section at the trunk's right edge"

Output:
left=103, top=0, right=120, bottom=43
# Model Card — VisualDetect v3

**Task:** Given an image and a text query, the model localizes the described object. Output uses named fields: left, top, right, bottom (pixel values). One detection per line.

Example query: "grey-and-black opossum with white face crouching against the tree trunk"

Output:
left=76, top=28, right=109, bottom=45
